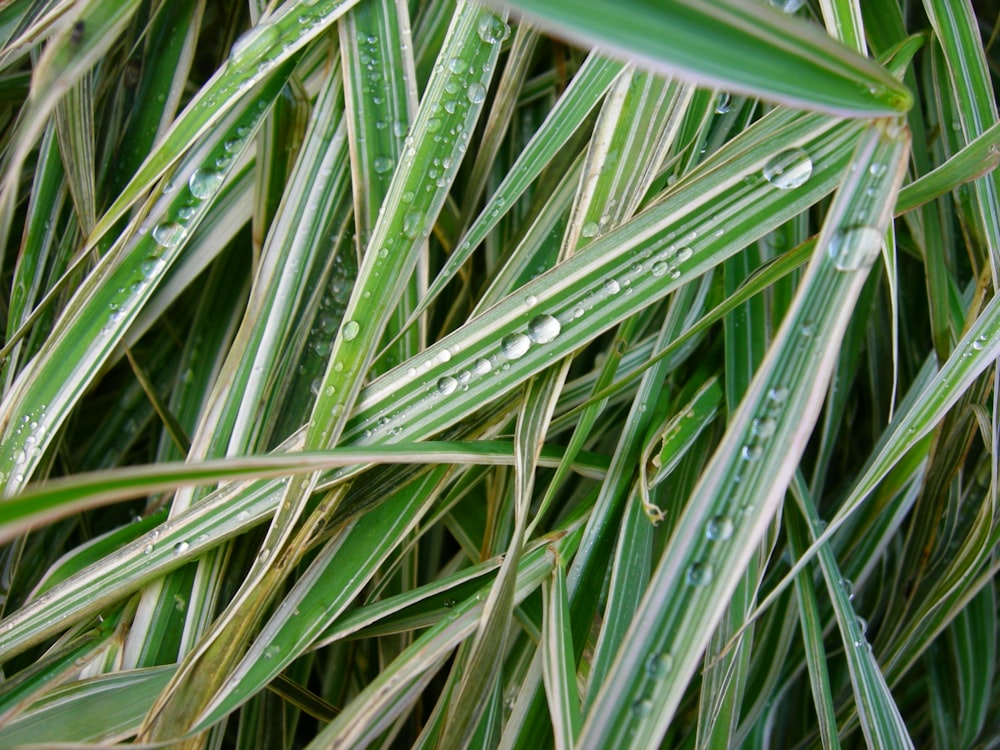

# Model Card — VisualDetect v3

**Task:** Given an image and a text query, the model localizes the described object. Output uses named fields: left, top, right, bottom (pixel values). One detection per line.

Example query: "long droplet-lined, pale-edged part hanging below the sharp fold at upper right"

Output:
left=580, top=122, right=909, bottom=748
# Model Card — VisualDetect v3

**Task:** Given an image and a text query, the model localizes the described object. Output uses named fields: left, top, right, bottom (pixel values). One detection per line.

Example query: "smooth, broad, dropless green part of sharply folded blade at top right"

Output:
left=496, top=0, right=913, bottom=117
